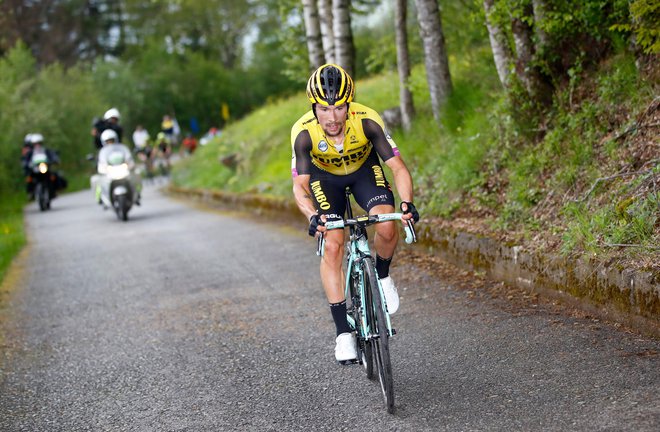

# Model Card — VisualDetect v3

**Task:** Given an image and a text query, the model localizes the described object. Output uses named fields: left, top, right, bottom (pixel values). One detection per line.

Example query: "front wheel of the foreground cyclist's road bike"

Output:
left=364, top=259, right=394, bottom=414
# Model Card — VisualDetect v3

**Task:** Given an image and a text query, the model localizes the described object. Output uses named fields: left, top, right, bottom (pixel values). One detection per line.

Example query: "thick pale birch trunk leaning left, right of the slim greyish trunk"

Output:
left=415, top=0, right=452, bottom=120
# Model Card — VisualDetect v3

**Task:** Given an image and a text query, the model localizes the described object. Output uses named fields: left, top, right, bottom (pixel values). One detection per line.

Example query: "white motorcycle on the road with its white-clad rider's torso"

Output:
left=97, top=152, right=142, bottom=221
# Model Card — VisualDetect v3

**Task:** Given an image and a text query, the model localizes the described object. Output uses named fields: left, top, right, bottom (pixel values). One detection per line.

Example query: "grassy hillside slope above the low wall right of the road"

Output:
left=174, top=56, right=660, bottom=280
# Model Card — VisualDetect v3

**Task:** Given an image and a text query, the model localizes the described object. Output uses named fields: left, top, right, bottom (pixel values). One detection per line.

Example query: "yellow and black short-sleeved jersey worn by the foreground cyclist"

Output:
left=291, top=102, right=399, bottom=177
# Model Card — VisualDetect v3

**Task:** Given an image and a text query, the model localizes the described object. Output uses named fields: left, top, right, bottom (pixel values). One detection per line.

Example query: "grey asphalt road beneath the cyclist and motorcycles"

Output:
left=0, top=186, right=660, bottom=432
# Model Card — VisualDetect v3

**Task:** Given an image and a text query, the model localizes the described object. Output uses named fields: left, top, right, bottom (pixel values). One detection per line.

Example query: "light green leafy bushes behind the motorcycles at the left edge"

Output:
left=0, top=43, right=103, bottom=192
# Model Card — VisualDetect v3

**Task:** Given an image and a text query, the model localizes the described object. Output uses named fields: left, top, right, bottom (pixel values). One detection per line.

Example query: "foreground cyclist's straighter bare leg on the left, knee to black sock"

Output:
left=321, top=230, right=344, bottom=303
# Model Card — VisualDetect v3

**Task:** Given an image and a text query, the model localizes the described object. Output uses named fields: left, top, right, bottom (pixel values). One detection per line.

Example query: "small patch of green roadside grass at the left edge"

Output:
left=0, top=194, right=25, bottom=282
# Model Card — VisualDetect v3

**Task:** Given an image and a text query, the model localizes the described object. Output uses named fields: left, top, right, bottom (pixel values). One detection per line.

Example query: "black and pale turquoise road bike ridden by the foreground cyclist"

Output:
left=317, top=188, right=417, bottom=414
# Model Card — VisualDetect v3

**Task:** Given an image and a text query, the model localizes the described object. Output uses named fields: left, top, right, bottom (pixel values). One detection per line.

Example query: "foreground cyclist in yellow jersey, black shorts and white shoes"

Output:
left=291, top=64, right=419, bottom=363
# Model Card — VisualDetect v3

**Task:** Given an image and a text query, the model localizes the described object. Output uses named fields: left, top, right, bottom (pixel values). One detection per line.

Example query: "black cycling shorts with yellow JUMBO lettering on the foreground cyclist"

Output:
left=309, top=149, right=394, bottom=220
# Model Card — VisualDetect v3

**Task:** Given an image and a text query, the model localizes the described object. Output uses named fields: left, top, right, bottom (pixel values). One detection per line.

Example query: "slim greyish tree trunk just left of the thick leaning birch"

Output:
left=394, top=0, right=415, bottom=131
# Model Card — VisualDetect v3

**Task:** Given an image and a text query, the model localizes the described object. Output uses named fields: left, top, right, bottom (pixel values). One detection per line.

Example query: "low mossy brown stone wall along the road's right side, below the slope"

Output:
left=165, top=185, right=660, bottom=338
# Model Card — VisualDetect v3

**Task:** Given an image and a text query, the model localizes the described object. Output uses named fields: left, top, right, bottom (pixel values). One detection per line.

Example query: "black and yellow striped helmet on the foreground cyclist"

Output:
left=307, top=63, right=355, bottom=106
